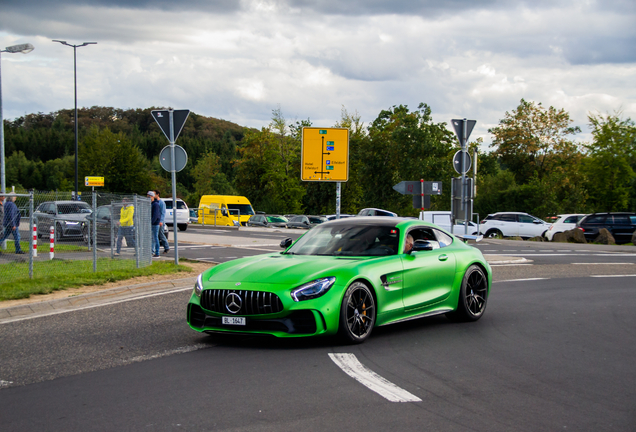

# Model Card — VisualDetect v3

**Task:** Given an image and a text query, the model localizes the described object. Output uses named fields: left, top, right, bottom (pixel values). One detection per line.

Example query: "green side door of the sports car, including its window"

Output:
left=401, top=227, right=455, bottom=310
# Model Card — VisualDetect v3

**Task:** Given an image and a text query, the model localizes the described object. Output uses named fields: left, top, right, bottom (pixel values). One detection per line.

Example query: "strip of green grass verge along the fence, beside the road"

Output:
left=0, top=258, right=193, bottom=301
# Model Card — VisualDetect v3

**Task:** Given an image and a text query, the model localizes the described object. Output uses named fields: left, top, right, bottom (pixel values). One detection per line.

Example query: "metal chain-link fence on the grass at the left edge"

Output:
left=0, top=192, right=152, bottom=283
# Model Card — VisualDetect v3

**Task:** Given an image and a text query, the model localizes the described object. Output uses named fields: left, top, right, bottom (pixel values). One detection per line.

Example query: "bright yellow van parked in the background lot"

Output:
left=198, top=195, right=254, bottom=226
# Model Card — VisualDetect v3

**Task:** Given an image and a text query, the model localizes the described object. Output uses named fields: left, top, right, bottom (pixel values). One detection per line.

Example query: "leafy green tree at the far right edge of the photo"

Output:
left=584, top=113, right=636, bottom=211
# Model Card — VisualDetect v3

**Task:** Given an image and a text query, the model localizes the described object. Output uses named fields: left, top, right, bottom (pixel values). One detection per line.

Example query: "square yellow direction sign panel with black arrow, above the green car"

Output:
left=300, top=127, right=349, bottom=182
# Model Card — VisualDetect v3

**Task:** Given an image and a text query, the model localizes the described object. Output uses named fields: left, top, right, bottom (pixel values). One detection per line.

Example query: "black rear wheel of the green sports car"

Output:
left=448, top=264, right=488, bottom=321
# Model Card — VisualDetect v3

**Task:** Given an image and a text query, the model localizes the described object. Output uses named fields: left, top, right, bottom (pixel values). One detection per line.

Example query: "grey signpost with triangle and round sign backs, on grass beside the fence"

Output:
left=151, top=108, right=190, bottom=265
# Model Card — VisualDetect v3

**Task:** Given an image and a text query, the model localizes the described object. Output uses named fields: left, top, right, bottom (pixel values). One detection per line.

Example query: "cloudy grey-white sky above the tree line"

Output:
left=0, top=0, right=636, bottom=143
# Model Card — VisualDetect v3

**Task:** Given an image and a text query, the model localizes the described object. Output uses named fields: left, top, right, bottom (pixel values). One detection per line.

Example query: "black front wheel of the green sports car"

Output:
left=338, top=282, right=377, bottom=344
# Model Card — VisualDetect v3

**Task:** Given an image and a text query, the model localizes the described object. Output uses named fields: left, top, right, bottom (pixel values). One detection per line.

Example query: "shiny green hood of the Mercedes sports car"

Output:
left=209, top=254, right=369, bottom=285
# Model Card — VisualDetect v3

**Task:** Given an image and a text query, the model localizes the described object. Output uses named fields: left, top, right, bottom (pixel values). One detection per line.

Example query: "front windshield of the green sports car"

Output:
left=286, top=223, right=399, bottom=256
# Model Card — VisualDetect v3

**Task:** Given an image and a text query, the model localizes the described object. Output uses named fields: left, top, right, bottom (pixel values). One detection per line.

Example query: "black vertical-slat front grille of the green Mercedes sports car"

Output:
left=201, top=290, right=283, bottom=315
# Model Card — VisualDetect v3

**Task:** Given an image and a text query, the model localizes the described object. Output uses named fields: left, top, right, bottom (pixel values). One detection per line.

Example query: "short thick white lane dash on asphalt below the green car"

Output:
left=329, top=353, right=422, bottom=402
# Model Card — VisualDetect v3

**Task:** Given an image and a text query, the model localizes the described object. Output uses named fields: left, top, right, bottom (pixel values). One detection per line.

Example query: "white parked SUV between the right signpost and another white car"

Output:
left=479, top=212, right=550, bottom=238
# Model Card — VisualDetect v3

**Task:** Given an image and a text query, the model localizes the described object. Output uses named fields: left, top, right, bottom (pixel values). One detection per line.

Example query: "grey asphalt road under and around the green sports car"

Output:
left=0, top=229, right=636, bottom=431
